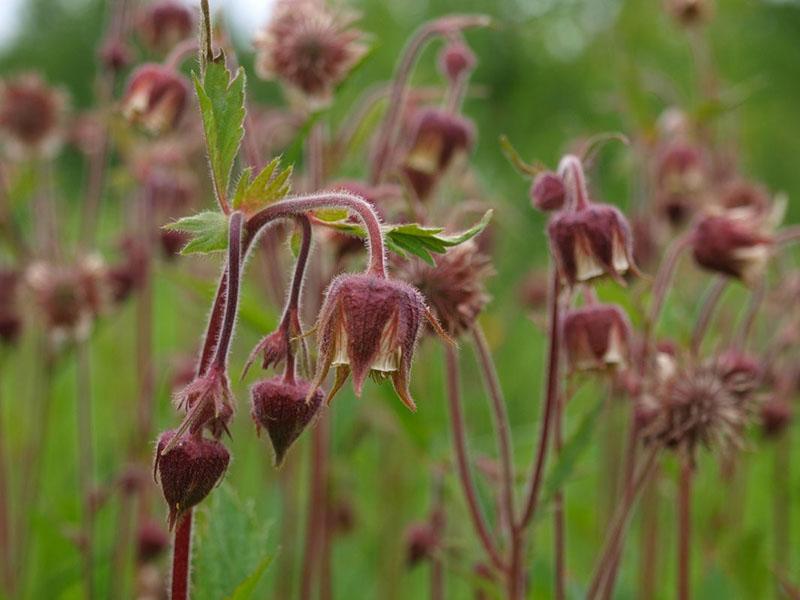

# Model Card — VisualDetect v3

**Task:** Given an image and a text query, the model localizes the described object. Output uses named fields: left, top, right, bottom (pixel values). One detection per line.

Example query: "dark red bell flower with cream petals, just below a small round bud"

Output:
left=547, top=203, right=638, bottom=286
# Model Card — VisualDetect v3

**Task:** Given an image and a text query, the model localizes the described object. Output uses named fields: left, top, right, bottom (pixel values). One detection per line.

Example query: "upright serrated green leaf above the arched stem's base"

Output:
left=192, top=62, right=246, bottom=203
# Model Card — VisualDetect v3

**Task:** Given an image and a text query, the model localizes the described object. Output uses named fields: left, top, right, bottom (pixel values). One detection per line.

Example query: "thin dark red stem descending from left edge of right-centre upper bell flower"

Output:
left=517, top=268, right=561, bottom=529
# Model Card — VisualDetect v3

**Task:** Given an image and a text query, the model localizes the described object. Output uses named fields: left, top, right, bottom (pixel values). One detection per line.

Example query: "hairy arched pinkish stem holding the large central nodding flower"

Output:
left=244, top=191, right=386, bottom=278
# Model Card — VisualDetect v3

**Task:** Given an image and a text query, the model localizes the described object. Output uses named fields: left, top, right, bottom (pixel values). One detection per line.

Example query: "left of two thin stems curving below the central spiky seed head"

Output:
left=444, top=344, right=506, bottom=571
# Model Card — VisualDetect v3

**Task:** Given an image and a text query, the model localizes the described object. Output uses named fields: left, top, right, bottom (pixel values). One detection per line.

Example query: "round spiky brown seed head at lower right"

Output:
left=643, top=362, right=754, bottom=457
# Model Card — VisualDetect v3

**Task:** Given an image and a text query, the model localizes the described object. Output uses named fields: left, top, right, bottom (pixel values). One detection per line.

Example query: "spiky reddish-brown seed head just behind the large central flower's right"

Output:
left=397, top=242, right=494, bottom=337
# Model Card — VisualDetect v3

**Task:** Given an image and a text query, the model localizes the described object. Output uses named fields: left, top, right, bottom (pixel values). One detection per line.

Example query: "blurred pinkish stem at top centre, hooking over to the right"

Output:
left=369, top=15, right=490, bottom=185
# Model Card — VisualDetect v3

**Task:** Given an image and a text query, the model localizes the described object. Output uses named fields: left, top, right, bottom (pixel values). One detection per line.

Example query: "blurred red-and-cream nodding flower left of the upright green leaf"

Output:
left=121, top=63, right=189, bottom=134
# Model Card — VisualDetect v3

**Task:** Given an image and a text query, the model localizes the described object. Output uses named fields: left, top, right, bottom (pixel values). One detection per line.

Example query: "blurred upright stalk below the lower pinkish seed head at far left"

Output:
left=76, top=340, right=94, bottom=599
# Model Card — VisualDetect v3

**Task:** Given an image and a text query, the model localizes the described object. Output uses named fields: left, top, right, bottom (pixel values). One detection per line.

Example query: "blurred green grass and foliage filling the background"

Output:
left=0, top=0, right=800, bottom=599
